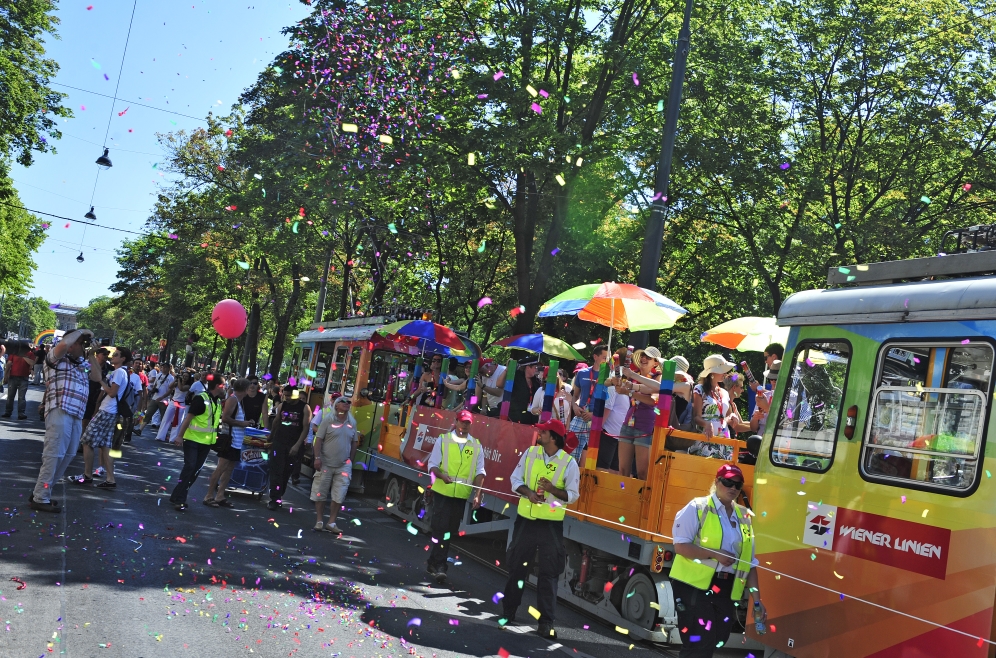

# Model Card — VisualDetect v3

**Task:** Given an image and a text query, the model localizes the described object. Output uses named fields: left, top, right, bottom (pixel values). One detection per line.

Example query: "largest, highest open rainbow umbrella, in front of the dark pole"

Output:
left=539, top=282, right=688, bottom=348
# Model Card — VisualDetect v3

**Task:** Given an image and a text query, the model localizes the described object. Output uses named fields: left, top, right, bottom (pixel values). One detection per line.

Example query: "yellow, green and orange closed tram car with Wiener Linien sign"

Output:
left=753, top=241, right=996, bottom=658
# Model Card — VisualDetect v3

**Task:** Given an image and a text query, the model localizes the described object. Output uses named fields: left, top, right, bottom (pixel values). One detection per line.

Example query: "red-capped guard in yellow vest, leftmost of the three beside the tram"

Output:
left=425, top=409, right=484, bottom=583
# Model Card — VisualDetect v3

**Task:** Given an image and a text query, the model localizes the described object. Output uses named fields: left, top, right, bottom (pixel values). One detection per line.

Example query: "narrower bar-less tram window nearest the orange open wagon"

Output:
left=771, top=341, right=851, bottom=472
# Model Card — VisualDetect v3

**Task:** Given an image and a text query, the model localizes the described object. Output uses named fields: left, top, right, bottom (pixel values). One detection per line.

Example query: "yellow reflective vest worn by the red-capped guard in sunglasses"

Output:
left=669, top=496, right=754, bottom=601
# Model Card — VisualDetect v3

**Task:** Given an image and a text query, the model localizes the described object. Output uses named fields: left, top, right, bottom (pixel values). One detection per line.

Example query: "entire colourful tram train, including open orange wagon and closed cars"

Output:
left=297, top=245, right=996, bottom=658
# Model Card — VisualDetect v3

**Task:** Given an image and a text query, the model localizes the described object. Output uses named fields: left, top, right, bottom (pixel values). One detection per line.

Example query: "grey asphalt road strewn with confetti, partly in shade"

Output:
left=0, top=386, right=746, bottom=658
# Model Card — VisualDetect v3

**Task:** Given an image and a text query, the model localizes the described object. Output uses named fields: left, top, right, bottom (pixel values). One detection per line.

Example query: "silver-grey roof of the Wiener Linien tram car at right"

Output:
left=778, top=276, right=996, bottom=327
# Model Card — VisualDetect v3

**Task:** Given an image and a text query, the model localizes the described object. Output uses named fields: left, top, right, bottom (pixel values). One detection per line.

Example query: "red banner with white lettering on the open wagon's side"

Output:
left=401, top=407, right=536, bottom=502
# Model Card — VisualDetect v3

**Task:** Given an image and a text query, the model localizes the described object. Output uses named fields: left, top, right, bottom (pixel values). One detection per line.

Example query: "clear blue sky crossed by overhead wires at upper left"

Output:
left=12, top=0, right=308, bottom=306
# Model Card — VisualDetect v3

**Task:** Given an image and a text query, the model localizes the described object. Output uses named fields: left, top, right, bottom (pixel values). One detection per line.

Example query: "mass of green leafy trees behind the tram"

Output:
left=87, top=0, right=996, bottom=373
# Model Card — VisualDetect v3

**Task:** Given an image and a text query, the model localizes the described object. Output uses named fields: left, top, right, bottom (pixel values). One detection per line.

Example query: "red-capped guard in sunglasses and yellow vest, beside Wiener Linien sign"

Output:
left=669, top=464, right=767, bottom=658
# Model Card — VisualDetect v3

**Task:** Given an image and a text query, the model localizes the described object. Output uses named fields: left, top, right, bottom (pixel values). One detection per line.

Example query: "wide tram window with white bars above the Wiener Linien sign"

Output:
left=861, top=342, right=993, bottom=491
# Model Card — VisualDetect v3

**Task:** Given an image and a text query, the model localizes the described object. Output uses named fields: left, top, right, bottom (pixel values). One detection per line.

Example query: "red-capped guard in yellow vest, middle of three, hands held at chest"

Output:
left=498, top=419, right=581, bottom=638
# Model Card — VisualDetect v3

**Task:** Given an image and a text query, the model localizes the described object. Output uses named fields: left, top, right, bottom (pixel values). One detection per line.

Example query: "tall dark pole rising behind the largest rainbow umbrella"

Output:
left=630, top=0, right=692, bottom=348
